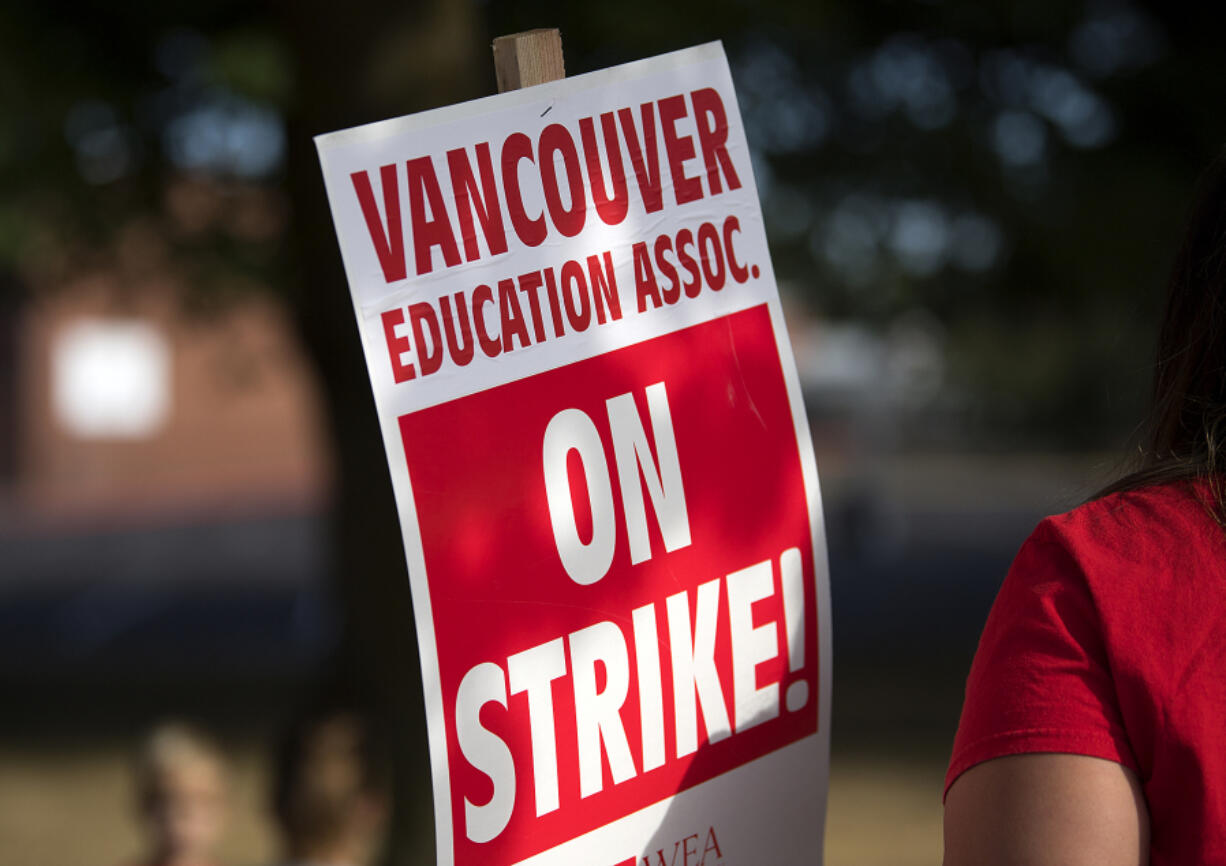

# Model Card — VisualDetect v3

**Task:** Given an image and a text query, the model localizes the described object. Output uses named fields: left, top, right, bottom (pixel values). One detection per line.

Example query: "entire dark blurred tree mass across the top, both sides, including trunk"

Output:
left=0, top=0, right=1226, bottom=862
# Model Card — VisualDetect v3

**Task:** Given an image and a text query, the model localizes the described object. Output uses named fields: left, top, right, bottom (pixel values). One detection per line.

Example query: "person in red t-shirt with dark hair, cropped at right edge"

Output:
left=945, top=158, right=1226, bottom=866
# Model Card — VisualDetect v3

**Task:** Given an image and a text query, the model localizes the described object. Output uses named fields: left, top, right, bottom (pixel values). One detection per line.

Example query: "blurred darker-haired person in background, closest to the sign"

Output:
left=272, top=708, right=389, bottom=866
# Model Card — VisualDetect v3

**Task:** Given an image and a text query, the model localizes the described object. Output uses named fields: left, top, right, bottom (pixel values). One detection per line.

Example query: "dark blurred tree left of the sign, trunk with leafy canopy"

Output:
left=0, top=0, right=489, bottom=862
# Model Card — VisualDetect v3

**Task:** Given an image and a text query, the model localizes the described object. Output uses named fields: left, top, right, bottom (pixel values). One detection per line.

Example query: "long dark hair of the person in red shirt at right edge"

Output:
left=1098, top=155, right=1226, bottom=515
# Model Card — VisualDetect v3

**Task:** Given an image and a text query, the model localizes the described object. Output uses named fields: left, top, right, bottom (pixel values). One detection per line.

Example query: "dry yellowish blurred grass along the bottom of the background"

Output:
left=0, top=743, right=944, bottom=866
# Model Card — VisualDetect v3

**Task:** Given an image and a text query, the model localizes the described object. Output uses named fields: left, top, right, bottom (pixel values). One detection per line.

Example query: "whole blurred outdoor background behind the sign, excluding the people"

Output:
left=0, top=0, right=1226, bottom=866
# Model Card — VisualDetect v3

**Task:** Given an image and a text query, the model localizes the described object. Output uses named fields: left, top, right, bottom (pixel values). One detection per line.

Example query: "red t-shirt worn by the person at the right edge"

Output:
left=945, top=485, right=1226, bottom=866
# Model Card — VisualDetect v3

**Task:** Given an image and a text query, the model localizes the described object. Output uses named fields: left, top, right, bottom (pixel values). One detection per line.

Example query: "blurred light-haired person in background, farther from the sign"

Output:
left=135, top=722, right=227, bottom=866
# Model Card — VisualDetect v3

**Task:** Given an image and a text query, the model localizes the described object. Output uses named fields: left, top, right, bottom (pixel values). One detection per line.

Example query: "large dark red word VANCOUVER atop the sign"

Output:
left=349, top=87, right=741, bottom=282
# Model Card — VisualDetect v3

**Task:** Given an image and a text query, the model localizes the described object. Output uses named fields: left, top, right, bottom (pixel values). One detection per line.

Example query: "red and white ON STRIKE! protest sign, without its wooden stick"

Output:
left=318, top=43, right=830, bottom=866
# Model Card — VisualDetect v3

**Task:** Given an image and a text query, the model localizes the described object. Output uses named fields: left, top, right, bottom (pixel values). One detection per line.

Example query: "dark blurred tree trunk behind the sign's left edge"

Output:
left=281, top=0, right=489, bottom=864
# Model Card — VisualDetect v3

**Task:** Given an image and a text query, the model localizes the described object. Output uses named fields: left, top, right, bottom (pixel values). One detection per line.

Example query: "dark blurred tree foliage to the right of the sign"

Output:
left=489, top=0, right=1226, bottom=449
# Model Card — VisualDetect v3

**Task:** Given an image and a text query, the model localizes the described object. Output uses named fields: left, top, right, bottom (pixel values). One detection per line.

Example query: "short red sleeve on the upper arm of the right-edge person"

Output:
left=945, top=521, right=1137, bottom=792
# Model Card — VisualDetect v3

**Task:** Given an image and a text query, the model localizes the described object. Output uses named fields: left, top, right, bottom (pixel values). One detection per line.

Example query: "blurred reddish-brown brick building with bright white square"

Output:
left=9, top=276, right=326, bottom=525
